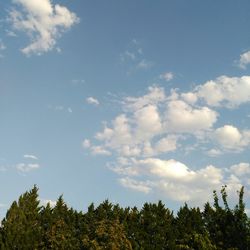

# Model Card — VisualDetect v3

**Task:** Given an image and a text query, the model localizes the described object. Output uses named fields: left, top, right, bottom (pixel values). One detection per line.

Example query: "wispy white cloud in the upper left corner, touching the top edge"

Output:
left=9, top=0, right=79, bottom=55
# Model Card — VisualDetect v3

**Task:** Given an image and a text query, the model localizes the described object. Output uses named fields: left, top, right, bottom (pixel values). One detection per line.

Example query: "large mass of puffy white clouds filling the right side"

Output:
left=83, top=76, right=250, bottom=205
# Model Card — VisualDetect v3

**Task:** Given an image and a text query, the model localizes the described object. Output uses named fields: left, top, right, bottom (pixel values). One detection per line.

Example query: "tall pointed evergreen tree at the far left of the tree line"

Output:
left=2, top=186, right=41, bottom=250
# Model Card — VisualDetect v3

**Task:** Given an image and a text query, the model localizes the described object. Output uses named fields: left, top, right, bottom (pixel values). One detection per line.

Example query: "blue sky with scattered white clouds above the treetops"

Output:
left=0, top=0, right=250, bottom=217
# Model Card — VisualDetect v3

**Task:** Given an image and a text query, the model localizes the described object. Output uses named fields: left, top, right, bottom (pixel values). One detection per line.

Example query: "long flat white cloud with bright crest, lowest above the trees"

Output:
left=113, top=158, right=246, bottom=204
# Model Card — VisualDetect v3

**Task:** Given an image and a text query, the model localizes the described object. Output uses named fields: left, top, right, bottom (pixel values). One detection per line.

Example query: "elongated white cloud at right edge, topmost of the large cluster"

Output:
left=195, top=76, right=250, bottom=108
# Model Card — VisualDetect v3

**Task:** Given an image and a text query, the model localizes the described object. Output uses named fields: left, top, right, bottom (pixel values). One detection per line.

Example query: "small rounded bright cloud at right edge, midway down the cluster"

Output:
left=214, top=125, right=250, bottom=150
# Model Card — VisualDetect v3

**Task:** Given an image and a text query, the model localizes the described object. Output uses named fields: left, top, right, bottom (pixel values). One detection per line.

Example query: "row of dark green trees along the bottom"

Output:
left=0, top=186, right=250, bottom=250
